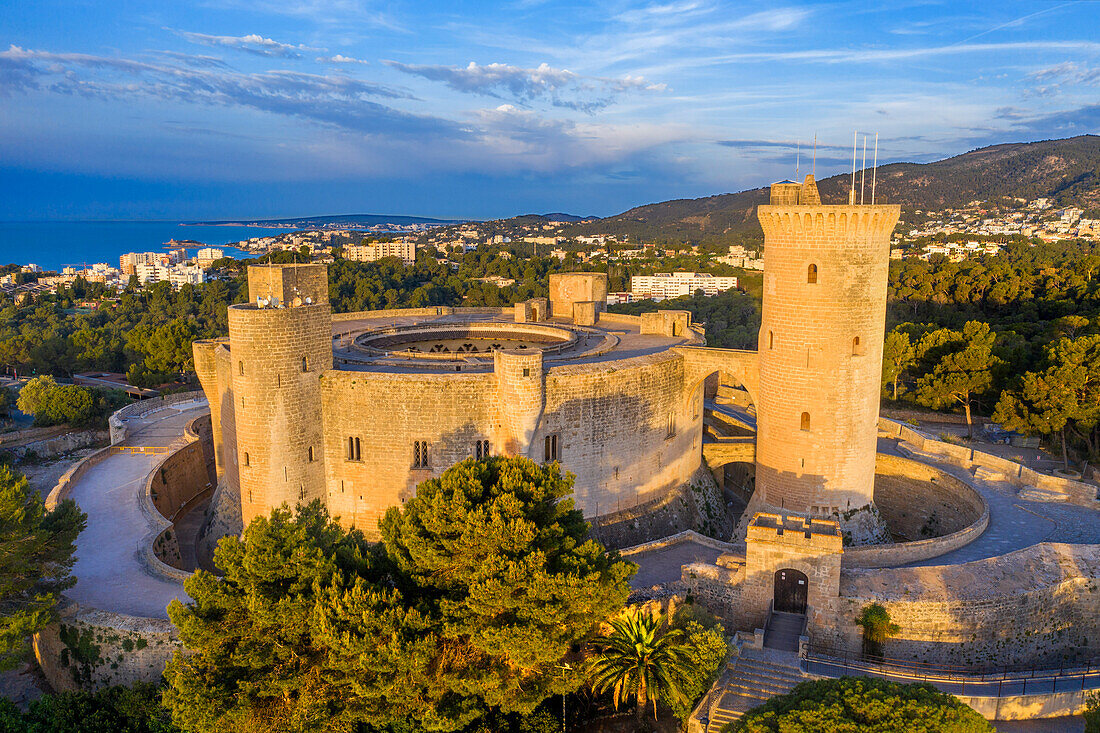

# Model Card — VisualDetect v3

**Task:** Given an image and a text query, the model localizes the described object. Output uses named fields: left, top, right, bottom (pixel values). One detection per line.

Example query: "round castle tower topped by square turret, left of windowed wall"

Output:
left=229, top=264, right=332, bottom=526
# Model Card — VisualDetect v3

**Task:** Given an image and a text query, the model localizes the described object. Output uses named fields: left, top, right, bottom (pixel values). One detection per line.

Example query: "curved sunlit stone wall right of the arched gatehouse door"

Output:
left=831, top=543, right=1100, bottom=669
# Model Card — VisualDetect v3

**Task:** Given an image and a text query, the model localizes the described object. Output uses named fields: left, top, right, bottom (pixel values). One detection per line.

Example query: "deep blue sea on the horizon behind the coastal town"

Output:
left=0, top=221, right=293, bottom=271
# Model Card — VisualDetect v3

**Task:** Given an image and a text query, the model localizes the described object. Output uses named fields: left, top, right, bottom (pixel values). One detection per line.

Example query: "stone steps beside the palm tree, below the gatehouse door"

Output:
left=706, top=649, right=813, bottom=733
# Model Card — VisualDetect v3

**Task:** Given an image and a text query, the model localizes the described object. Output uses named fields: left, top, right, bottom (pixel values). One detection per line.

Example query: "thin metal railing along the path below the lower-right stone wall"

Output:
left=801, top=644, right=1100, bottom=698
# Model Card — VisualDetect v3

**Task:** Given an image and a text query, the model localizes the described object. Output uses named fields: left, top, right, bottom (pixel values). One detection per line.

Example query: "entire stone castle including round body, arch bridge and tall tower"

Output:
left=194, top=176, right=899, bottom=541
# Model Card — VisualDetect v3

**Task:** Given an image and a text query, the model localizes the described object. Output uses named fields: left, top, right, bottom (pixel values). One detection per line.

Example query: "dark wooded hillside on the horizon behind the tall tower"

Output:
left=569, top=135, right=1100, bottom=241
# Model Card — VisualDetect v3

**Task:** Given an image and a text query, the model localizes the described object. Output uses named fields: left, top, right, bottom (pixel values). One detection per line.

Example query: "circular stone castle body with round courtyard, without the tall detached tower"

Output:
left=195, top=264, right=717, bottom=534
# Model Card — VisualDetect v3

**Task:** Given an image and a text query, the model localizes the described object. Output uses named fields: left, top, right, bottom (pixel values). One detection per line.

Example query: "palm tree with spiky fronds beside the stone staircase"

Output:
left=590, top=608, right=691, bottom=727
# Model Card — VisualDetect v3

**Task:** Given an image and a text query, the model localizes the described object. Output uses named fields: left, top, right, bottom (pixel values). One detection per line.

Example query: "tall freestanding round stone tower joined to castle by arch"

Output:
left=750, top=176, right=900, bottom=544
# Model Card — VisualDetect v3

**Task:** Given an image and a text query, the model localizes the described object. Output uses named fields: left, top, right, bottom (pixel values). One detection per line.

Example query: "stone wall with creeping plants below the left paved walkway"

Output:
left=34, top=603, right=182, bottom=691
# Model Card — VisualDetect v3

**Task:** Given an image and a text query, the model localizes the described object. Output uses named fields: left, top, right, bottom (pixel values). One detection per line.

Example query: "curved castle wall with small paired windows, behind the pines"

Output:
left=321, top=345, right=699, bottom=534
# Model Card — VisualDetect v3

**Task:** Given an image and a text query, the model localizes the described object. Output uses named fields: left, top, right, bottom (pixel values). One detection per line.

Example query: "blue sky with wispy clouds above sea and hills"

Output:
left=0, top=0, right=1100, bottom=219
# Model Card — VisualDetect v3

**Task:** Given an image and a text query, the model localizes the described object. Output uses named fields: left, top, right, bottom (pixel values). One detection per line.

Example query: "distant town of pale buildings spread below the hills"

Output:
left=0, top=198, right=1100, bottom=305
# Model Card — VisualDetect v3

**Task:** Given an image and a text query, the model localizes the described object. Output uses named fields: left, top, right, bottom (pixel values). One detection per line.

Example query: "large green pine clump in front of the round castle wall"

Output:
left=165, top=458, right=634, bottom=733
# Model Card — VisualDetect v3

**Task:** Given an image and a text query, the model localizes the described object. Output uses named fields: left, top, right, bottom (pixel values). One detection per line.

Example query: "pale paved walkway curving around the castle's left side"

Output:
left=65, top=403, right=207, bottom=619
